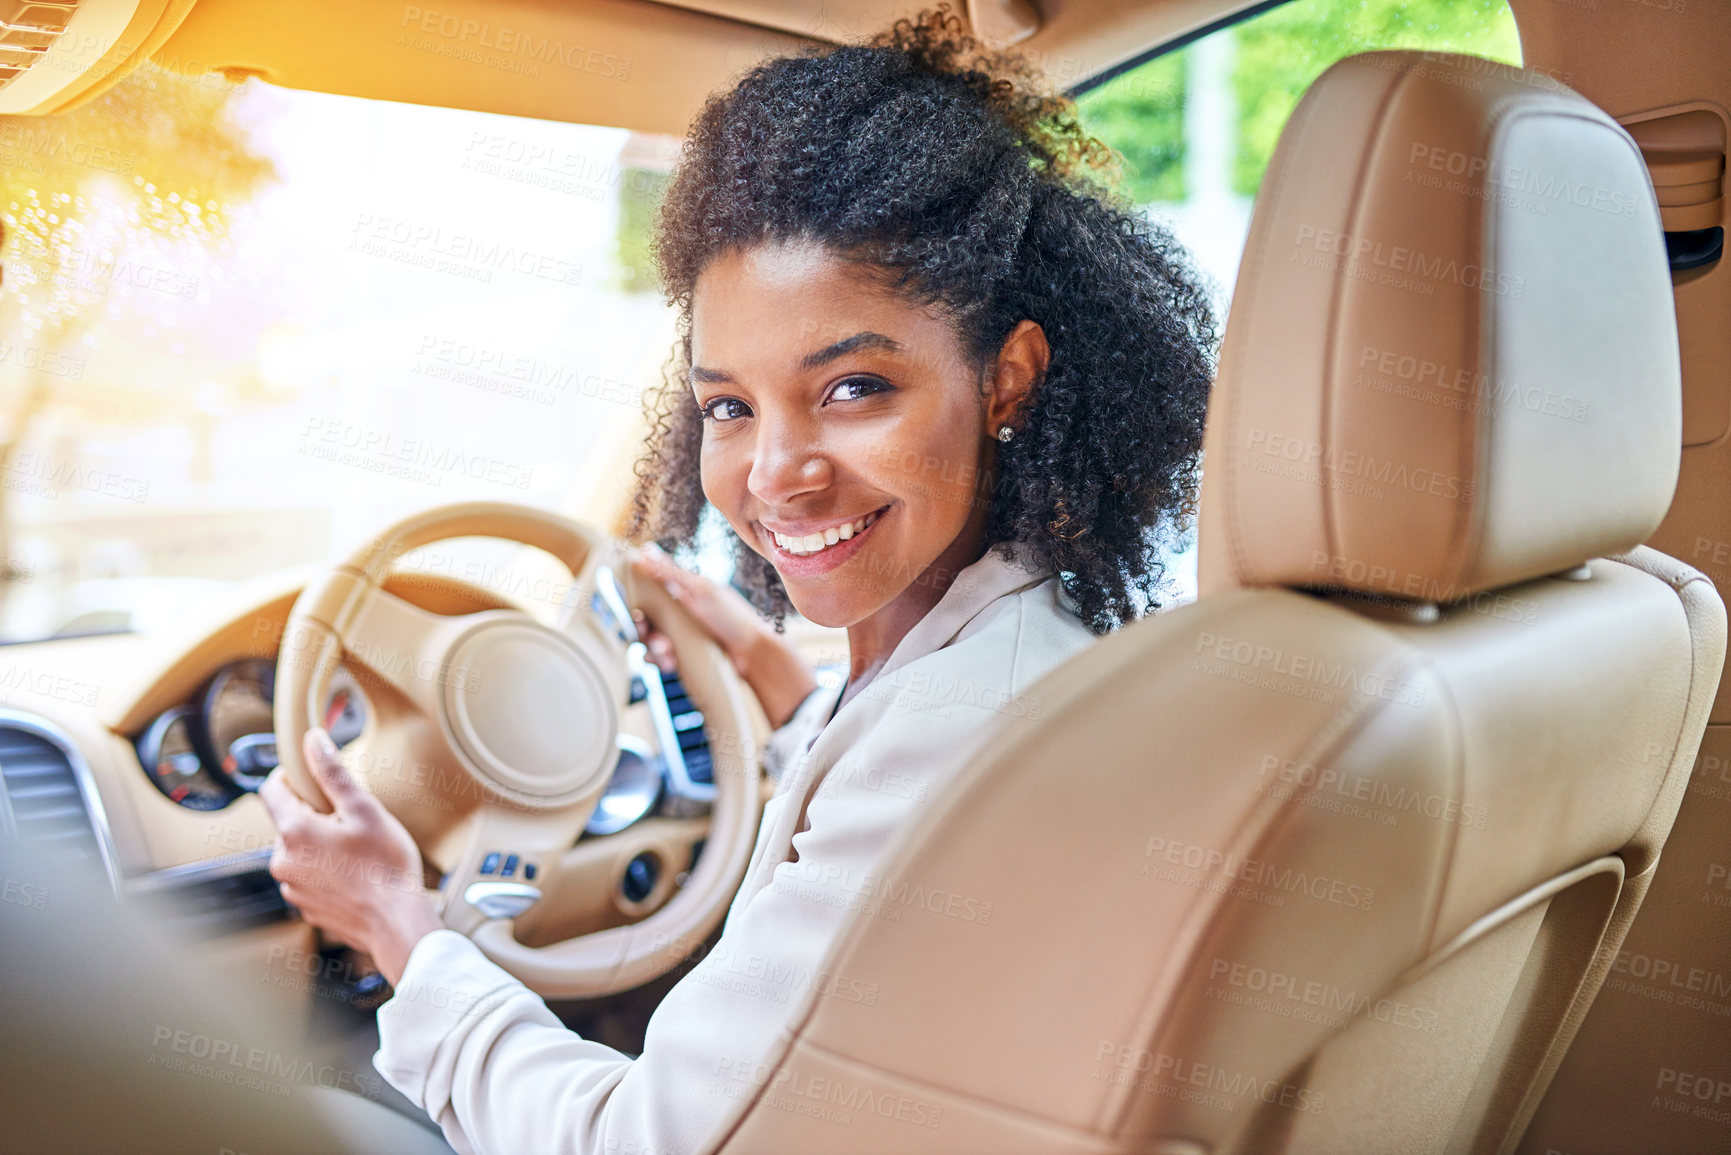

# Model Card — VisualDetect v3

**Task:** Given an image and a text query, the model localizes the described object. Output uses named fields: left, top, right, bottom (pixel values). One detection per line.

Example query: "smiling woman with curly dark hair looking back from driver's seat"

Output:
left=265, top=10, right=1213, bottom=1153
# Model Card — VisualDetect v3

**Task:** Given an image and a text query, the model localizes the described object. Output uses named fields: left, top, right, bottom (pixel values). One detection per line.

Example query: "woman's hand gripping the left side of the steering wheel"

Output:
left=258, top=727, right=443, bottom=987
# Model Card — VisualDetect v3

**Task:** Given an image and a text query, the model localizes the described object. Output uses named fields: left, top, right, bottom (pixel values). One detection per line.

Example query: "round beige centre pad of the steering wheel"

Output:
left=443, top=618, right=618, bottom=809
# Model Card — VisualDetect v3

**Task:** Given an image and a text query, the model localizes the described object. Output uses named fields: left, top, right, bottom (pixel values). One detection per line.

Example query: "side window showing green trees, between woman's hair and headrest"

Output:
left=1078, top=0, right=1522, bottom=597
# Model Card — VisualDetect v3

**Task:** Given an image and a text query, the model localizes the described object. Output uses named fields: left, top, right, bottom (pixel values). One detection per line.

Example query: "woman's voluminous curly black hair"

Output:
left=625, top=3, right=1215, bottom=634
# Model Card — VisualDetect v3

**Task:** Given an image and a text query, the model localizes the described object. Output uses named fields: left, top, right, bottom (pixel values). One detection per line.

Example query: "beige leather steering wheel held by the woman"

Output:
left=273, top=502, right=767, bottom=997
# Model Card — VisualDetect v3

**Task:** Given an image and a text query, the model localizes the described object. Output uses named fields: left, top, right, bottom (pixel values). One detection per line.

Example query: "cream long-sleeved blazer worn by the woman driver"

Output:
left=372, top=544, right=1094, bottom=1155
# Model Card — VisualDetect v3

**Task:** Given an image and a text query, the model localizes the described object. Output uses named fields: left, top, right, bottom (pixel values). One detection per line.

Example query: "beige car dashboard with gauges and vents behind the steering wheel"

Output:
left=0, top=568, right=737, bottom=976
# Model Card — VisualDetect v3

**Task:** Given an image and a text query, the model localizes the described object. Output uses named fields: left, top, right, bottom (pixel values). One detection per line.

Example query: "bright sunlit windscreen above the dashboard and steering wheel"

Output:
left=0, top=68, right=675, bottom=641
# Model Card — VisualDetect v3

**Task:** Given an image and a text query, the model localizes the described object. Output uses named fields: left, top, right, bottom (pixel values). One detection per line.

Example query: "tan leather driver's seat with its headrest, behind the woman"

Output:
left=722, top=52, right=1724, bottom=1155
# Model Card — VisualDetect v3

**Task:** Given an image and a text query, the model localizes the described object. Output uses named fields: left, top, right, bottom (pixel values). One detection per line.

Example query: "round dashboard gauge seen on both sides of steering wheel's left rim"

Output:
left=204, top=658, right=367, bottom=791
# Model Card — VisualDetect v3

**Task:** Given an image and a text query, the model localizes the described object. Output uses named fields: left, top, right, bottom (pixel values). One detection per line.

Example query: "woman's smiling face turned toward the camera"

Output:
left=691, top=242, right=1044, bottom=627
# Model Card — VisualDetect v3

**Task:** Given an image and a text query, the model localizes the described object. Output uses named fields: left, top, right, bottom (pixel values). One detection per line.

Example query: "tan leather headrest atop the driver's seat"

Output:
left=1200, top=52, right=1683, bottom=603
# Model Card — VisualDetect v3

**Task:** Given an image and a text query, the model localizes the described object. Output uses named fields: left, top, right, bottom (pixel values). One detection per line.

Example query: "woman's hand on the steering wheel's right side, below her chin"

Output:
left=632, top=542, right=817, bottom=727
